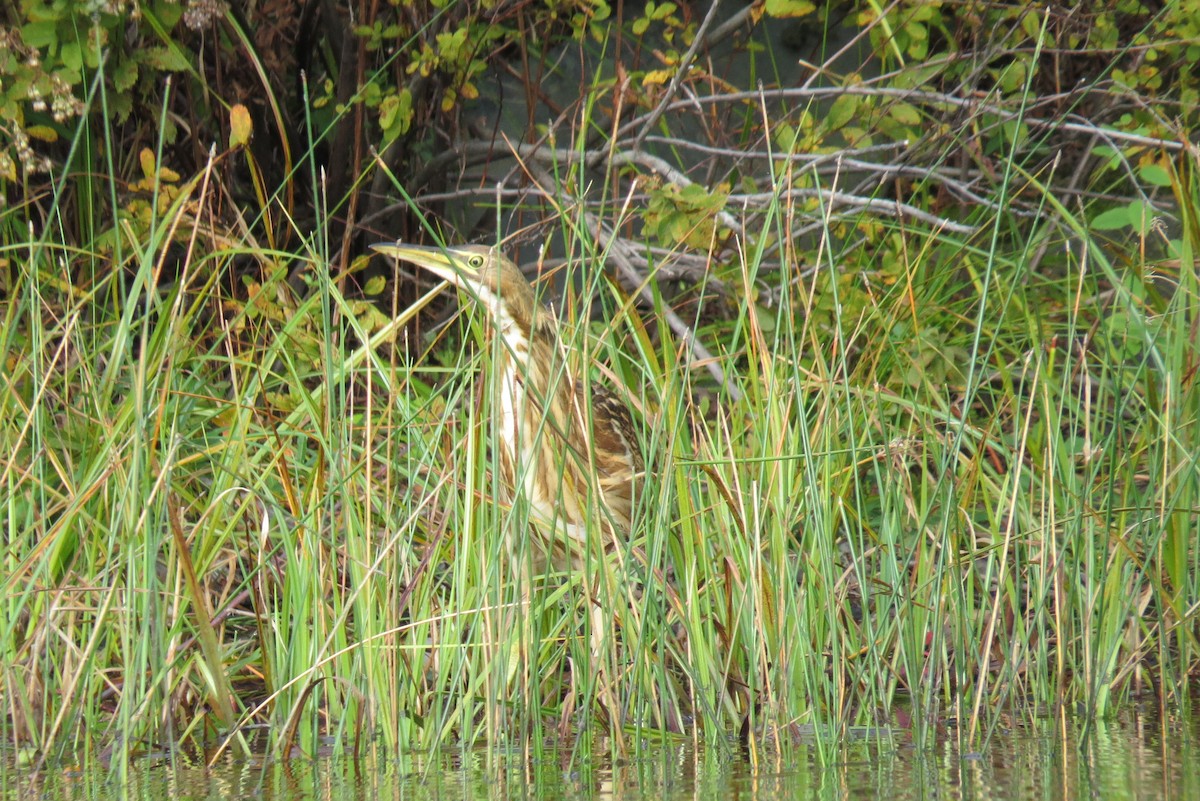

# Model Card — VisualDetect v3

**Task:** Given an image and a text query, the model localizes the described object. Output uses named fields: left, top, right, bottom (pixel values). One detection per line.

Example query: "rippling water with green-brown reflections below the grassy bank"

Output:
left=0, top=706, right=1200, bottom=801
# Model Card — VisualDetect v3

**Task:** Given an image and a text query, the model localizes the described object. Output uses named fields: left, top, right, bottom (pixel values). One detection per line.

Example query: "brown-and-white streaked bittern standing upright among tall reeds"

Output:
left=373, top=242, right=643, bottom=570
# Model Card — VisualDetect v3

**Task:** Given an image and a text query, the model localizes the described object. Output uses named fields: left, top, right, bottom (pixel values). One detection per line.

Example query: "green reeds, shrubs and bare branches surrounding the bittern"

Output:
left=0, top=0, right=1200, bottom=761
